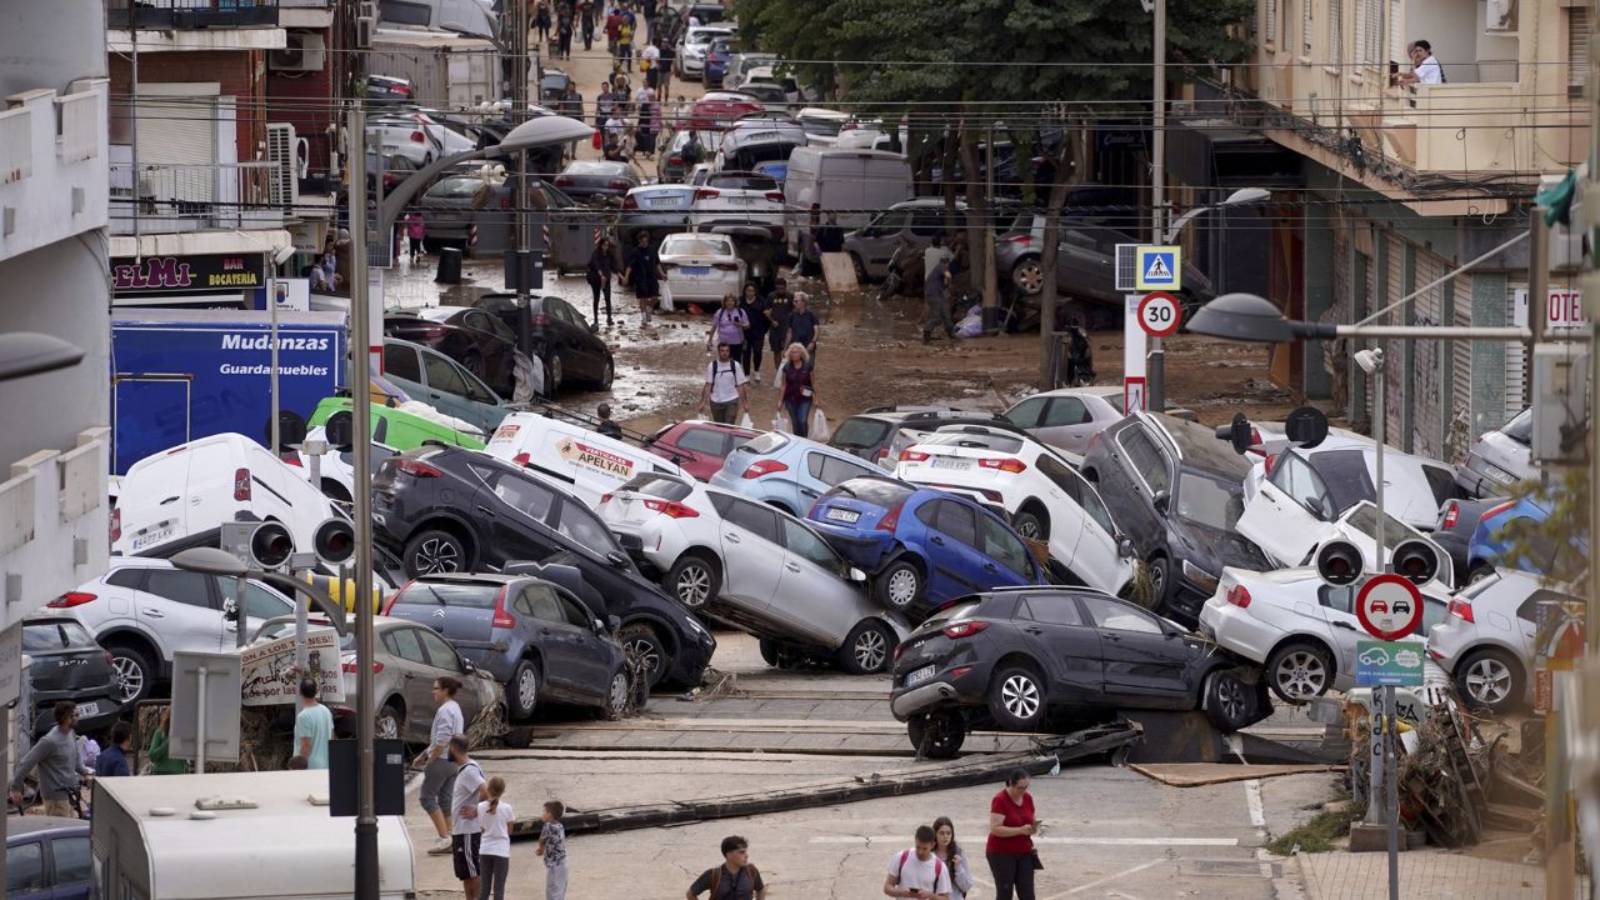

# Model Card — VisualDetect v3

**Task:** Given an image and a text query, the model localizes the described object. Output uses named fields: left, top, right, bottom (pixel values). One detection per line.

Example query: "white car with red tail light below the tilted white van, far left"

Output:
left=48, top=556, right=294, bottom=705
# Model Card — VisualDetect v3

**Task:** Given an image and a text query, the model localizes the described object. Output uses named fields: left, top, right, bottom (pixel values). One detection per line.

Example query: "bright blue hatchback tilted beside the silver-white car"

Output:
left=810, top=476, right=1048, bottom=621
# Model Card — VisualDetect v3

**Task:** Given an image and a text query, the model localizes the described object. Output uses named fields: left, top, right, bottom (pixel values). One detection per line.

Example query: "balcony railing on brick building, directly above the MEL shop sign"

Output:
left=110, top=162, right=283, bottom=234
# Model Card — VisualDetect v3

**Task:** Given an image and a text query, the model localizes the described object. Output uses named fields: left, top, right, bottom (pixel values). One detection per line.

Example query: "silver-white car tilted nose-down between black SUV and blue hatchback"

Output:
left=600, top=474, right=910, bottom=674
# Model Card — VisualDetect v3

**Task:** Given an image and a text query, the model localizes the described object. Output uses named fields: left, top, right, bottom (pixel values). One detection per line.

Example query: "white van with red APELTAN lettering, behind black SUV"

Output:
left=483, top=413, right=693, bottom=508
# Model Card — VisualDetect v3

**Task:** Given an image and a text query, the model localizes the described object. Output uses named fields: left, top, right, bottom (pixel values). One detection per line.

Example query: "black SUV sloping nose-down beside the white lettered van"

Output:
left=373, top=445, right=717, bottom=685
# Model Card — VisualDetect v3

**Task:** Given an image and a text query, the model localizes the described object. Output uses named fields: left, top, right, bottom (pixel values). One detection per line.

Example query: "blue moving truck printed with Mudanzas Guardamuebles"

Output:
left=110, top=307, right=347, bottom=476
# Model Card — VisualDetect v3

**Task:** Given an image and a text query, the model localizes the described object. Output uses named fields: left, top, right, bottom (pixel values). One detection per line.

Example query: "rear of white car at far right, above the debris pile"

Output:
left=1427, top=569, right=1548, bottom=713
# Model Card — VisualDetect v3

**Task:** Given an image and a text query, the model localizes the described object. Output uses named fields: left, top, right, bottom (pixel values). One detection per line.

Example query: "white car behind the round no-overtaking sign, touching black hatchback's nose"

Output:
left=1200, top=567, right=1448, bottom=703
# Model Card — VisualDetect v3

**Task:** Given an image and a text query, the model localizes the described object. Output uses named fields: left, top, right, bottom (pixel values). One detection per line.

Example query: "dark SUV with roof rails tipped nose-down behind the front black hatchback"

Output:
left=1080, top=412, right=1274, bottom=626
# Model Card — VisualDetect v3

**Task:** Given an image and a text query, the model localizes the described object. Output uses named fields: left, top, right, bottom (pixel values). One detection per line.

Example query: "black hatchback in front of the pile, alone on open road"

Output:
left=890, top=586, right=1272, bottom=757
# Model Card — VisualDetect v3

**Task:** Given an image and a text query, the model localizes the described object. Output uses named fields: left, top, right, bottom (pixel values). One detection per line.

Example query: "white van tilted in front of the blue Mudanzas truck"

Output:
left=110, top=434, right=338, bottom=557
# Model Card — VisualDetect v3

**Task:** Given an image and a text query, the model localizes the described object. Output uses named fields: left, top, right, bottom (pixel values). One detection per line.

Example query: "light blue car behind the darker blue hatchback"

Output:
left=710, top=431, right=883, bottom=517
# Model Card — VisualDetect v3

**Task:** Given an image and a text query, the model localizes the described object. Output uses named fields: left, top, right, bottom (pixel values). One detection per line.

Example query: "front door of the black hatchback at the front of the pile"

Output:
left=1078, top=594, right=1192, bottom=709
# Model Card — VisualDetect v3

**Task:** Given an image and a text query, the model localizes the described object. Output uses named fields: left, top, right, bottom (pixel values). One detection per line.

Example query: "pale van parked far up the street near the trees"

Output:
left=784, top=147, right=912, bottom=255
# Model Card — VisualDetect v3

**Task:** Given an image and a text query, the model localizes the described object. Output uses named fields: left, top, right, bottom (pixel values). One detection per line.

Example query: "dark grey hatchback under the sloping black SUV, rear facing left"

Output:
left=384, top=575, right=632, bottom=721
